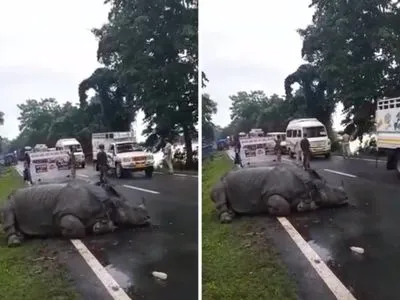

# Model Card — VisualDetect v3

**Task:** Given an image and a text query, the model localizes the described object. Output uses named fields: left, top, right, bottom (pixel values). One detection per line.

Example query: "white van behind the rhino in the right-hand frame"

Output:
left=286, top=118, right=331, bottom=158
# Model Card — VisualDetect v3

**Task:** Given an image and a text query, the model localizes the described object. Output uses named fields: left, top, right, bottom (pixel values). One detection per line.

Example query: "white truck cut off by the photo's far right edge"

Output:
left=375, top=97, right=400, bottom=178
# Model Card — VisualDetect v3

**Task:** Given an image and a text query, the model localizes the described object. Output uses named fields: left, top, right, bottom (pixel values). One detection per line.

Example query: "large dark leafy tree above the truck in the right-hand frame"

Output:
left=299, top=0, right=400, bottom=136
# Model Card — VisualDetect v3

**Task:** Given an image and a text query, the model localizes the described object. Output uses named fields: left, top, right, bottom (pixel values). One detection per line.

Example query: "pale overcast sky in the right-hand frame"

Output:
left=199, top=0, right=342, bottom=129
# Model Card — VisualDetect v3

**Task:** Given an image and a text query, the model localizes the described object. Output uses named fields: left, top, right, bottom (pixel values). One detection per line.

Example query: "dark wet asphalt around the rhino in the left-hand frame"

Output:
left=15, top=167, right=198, bottom=300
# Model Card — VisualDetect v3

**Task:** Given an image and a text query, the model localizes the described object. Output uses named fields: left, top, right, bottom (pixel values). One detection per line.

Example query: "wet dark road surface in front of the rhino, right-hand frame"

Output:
left=288, top=157, right=400, bottom=300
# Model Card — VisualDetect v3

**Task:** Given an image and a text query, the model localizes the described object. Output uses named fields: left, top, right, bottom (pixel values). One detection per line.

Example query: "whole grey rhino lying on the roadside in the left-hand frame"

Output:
left=1, top=181, right=150, bottom=247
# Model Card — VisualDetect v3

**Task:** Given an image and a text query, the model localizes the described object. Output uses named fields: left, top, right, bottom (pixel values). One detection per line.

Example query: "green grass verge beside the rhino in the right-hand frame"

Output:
left=202, top=153, right=297, bottom=300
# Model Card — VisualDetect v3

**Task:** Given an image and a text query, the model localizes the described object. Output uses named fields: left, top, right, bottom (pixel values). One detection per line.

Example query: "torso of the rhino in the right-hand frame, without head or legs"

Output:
left=225, top=165, right=307, bottom=214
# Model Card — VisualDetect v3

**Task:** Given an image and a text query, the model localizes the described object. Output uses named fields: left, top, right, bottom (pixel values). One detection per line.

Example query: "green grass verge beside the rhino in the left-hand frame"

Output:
left=0, top=168, right=78, bottom=300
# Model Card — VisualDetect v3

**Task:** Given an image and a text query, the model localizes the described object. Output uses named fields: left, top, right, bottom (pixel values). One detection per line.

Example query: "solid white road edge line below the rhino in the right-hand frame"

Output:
left=277, top=217, right=356, bottom=300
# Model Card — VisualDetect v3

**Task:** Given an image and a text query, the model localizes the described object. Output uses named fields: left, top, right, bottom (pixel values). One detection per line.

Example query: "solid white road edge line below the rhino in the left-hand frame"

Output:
left=71, top=240, right=132, bottom=300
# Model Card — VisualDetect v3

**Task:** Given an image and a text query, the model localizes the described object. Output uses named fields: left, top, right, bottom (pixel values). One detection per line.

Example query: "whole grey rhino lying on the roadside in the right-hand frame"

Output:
left=211, top=162, right=348, bottom=223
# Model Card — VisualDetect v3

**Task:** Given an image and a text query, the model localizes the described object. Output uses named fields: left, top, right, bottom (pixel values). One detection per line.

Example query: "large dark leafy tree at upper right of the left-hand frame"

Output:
left=89, top=0, right=198, bottom=169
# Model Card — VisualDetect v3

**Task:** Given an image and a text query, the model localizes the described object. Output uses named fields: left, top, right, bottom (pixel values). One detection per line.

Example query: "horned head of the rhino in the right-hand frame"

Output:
left=315, top=180, right=349, bottom=207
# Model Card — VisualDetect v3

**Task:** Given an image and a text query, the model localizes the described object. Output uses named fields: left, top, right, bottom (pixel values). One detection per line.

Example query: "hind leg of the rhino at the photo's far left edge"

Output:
left=2, top=195, right=22, bottom=247
